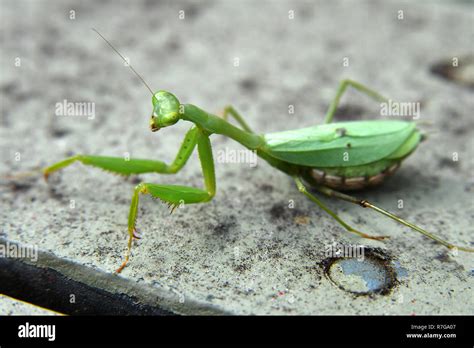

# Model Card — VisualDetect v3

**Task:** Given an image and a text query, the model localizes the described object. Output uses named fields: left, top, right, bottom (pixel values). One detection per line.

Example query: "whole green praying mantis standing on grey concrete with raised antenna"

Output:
left=39, top=29, right=474, bottom=273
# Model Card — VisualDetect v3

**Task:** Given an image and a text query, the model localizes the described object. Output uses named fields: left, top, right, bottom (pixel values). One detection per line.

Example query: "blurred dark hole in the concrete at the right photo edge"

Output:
left=430, top=56, right=474, bottom=89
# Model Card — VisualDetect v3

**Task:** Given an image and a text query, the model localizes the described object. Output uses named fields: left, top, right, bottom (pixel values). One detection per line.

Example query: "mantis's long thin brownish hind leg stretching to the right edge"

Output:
left=316, top=186, right=474, bottom=252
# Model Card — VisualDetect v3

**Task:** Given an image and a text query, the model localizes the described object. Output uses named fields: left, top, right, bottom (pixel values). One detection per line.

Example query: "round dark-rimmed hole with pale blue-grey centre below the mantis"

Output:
left=323, top=248, right=406, bottom=295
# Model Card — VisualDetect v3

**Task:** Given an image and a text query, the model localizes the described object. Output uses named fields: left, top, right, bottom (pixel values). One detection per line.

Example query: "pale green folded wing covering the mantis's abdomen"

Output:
left=264, top=120, right=421, bottom=167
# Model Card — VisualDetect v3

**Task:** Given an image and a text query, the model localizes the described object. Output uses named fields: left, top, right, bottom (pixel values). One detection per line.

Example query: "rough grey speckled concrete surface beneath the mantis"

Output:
left=0, top=0, right=474, bottom=314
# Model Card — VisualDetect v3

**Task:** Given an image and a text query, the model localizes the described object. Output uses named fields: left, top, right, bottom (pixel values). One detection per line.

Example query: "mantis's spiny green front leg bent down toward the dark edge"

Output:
left=116, top=131, right=216, bottom=273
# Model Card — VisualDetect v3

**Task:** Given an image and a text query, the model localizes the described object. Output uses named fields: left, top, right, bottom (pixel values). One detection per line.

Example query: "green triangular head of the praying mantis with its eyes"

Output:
left=150, top=91, right=181, bottom=132
